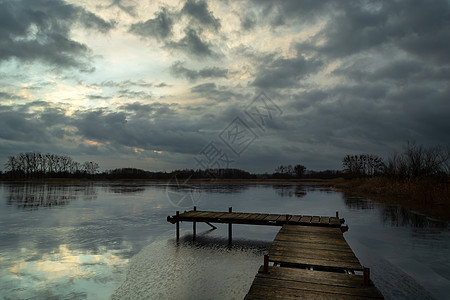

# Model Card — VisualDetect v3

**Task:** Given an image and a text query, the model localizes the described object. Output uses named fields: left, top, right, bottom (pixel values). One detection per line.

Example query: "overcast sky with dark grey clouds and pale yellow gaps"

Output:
left=0, top=0, right=450, bottom=173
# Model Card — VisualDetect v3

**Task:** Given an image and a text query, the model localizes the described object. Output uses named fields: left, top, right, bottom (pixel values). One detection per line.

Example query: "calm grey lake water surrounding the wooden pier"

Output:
left=0, top=181, right=450, bottom=299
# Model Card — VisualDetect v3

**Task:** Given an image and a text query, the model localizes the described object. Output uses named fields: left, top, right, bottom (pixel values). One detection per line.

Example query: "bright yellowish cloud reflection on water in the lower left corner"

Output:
left=0, top=244, right=129, bottom=299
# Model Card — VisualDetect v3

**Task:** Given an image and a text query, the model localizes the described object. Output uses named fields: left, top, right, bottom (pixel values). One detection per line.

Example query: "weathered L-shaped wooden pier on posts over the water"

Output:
left=167, top=207, right=383, bottom=299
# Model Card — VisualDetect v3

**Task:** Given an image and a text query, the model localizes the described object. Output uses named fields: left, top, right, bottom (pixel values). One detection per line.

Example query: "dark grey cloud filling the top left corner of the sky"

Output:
left=0, top=0, right=114, bottom=70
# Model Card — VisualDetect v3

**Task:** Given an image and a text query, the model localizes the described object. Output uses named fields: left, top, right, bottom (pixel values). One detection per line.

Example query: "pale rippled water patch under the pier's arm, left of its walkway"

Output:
left=112, top=236, right=271, bottom=299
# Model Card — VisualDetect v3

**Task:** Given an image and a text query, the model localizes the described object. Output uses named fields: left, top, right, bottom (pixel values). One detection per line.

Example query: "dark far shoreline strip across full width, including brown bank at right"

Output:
left=0, top=177, right=450, bottom=221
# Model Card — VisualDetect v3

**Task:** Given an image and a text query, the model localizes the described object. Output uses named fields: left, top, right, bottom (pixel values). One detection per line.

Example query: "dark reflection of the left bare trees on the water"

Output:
left=6, top=183, right=97, bottom=210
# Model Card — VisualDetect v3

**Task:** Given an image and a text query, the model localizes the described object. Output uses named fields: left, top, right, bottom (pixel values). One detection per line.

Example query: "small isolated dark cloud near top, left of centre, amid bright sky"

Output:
left=130, top=7, right=175, bottom=40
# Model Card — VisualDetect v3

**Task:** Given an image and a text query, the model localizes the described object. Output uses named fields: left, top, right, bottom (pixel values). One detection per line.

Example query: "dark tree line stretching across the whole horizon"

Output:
left=0, top=142, right=450, bottom=179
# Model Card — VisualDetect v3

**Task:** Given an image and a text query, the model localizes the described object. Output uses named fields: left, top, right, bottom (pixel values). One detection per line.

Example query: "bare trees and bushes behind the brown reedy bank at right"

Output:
left=342, top=142, right=450, bottom=179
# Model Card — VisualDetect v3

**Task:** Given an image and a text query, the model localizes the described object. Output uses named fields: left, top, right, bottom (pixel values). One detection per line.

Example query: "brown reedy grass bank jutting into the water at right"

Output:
left=323, top=177, right=450, bottom=221
